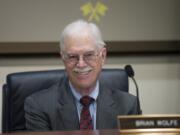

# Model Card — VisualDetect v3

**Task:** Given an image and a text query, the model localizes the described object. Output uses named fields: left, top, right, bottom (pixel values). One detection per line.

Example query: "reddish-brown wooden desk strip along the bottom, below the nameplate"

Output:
left=0, top=130, right=180, bottom=135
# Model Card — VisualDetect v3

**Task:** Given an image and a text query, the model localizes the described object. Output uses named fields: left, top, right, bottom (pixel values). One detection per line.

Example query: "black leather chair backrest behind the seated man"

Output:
left=2, top=69, right=129, bottom=133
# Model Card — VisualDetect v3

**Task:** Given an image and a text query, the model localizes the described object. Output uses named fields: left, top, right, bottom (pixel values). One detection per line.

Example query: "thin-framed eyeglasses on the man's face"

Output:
left=63, top=51, right=100, bottom=65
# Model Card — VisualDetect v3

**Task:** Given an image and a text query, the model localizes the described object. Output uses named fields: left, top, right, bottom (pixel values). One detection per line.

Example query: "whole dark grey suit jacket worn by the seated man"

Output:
left=24, top=79, right=137, bottom=131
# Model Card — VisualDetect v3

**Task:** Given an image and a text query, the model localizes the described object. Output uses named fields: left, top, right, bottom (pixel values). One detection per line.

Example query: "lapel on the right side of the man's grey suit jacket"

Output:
left=97, top=84, right=118, bottom=129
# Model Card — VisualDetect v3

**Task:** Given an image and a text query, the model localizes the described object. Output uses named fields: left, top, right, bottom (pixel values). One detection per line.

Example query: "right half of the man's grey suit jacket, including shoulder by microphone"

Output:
left=97, top=83, right=137, bottom=129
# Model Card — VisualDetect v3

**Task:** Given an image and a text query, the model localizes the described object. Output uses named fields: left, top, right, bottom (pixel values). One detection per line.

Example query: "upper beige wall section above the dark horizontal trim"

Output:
left=0, top=0, right=180, bottom=42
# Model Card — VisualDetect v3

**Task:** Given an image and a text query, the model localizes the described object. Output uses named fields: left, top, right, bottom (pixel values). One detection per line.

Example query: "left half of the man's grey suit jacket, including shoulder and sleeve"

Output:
left=24, top=80, right=79, bottom=131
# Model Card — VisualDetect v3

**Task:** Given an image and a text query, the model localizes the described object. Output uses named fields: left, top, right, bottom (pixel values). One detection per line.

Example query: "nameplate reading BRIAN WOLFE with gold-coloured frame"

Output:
left=118, top=115, right=180, bottom=132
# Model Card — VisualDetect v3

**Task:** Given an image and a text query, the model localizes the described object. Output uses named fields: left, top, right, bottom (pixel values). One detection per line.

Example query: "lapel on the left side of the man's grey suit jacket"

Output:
left=58, top=80, right=79, bottom=130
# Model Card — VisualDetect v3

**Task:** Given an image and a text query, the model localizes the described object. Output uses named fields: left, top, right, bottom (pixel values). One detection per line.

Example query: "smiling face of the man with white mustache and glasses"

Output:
left=62, top=36, right=106, bottom=91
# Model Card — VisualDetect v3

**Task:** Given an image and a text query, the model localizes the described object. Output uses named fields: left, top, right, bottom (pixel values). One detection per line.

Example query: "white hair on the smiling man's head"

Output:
left=60, top=20, right=106, bottom=50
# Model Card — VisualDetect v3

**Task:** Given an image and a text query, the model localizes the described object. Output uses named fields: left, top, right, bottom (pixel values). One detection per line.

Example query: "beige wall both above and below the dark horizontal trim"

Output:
left=0, top=0, right=180, bottom=133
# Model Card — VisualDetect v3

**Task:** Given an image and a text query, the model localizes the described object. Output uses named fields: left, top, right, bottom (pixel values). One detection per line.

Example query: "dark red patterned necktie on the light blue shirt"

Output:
left=80, top=96, right=94, bottom=129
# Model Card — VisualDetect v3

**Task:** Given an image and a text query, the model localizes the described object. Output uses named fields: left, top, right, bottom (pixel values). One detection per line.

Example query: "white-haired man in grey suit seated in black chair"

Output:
left=24, top=20, right=137, bottom=131
